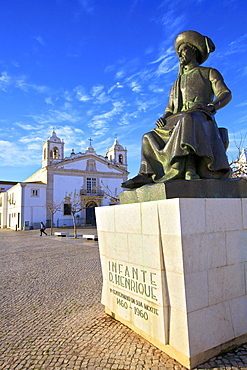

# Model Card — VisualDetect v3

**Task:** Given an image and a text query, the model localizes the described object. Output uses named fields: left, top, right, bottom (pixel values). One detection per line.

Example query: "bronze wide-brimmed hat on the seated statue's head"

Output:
left=174, top=31, right=215, bottom=64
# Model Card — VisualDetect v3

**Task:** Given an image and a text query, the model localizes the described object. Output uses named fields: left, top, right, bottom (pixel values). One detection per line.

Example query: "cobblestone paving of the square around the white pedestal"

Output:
left=0, top=229, right=247, bottom=370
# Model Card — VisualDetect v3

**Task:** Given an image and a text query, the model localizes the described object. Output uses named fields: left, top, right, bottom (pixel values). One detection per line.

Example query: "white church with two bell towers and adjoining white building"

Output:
left=0, top=130, right=128, bottom=230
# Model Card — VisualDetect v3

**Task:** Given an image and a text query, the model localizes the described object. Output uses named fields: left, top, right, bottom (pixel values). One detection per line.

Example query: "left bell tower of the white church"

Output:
left=42, top=130, right=64, bottom=167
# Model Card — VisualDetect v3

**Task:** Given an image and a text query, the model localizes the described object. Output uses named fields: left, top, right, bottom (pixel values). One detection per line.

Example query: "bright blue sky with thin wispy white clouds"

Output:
left=0, top=0, right=247, bottom=181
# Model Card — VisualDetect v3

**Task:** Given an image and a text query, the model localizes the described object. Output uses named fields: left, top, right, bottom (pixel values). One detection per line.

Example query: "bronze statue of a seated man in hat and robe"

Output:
left=122, top=31, right=231, bottom=189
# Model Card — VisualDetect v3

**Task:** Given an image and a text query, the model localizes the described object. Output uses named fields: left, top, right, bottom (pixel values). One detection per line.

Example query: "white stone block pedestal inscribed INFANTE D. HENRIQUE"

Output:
left=96, top=198, right=247, bottom=368
